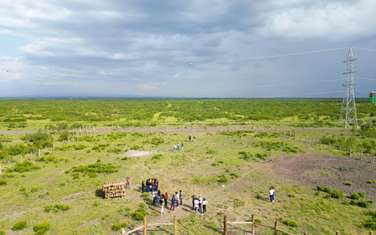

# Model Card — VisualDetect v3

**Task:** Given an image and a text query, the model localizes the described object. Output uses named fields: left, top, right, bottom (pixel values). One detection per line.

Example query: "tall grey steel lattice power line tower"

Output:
left=341, top=48, right=358, bottom=128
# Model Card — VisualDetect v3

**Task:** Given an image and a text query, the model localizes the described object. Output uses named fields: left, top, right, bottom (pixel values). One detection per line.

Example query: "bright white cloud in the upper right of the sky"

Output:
left=259, top=0, right=376, bottom=40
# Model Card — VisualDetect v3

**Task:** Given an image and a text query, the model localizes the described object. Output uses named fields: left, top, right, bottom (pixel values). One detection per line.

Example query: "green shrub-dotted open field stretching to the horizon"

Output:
left=0, top=99, right=376, bottom=234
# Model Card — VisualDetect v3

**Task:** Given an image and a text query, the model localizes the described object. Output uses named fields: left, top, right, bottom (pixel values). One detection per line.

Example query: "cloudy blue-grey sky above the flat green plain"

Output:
left=0, top=0, right=376, bottom=98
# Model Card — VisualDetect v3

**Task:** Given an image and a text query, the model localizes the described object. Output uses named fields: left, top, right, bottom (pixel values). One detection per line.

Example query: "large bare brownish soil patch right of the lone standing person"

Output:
left=271, top=156, right=376, bottom=203
